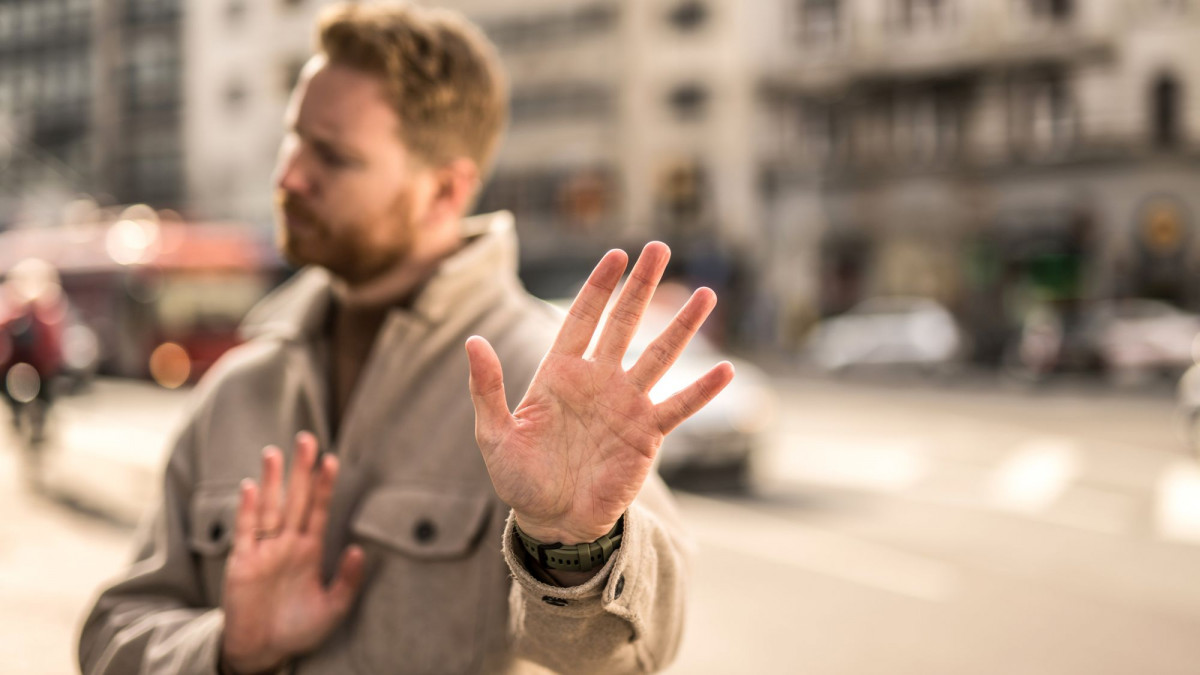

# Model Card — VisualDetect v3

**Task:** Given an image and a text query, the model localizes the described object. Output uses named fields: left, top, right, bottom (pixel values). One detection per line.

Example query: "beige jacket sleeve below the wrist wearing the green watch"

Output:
left=503, top=474, right=690, bottom=673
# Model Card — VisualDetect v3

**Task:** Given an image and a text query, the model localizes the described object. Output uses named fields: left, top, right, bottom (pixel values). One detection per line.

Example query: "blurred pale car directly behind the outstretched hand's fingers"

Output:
left=550, top=285, right=776, bottom=489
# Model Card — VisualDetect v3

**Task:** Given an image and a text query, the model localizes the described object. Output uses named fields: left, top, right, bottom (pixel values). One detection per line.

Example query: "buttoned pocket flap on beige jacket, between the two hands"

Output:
left=353, top=486, right=491, bottom=558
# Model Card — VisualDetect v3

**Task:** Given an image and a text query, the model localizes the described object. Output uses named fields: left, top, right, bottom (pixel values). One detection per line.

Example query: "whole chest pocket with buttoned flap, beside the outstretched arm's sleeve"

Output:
left=350, top=486, right=504, bottom=673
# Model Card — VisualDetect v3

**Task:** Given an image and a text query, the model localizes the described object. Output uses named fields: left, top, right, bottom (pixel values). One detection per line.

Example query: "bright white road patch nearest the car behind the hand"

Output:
left=764, top=437, right=930, bottom=492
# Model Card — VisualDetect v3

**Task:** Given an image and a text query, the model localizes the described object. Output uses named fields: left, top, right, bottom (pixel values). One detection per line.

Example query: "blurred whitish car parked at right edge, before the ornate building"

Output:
left=1082, top=299, right=1200, bottom=376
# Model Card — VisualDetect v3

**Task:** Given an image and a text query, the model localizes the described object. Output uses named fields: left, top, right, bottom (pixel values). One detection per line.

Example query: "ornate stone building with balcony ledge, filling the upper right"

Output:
left=760, top=0, right=1200, bottom=359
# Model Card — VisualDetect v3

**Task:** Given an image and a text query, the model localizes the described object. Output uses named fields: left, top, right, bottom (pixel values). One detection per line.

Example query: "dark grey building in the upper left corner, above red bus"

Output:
left=0, top=0, right=182, bottom=227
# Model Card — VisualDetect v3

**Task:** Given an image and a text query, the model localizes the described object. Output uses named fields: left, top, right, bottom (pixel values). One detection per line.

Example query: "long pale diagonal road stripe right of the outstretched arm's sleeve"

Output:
left=678, top=487, right=959, bottom=602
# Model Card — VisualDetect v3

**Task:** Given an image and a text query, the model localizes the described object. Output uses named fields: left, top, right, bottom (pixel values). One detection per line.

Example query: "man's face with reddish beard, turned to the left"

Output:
left=275, top=56, right=427, bottom=285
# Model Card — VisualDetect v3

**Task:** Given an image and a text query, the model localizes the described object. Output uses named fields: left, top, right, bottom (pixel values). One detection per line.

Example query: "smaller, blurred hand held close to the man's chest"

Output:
left=221, top=432, right=362, bottom=673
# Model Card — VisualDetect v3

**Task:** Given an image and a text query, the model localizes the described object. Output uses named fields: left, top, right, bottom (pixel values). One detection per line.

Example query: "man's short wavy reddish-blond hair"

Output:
left=317, top=2, right=509, bottom=172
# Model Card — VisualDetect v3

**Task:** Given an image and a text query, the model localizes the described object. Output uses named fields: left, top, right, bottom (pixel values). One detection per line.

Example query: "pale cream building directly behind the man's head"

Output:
left=187, top=0, right=760, bottom=267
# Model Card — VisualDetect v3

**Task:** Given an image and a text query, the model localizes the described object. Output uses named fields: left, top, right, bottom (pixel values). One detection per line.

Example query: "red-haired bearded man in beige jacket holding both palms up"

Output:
left=79, top=5, right=732, bottom=674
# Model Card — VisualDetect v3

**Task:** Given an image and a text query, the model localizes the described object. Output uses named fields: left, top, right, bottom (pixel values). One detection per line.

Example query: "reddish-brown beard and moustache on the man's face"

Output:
left=275, top=190, right=413, bottom=285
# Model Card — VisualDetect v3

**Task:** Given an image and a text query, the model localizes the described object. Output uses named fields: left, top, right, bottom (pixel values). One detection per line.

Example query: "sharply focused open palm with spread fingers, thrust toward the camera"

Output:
left=467, top=241, right=733, bottom=544
